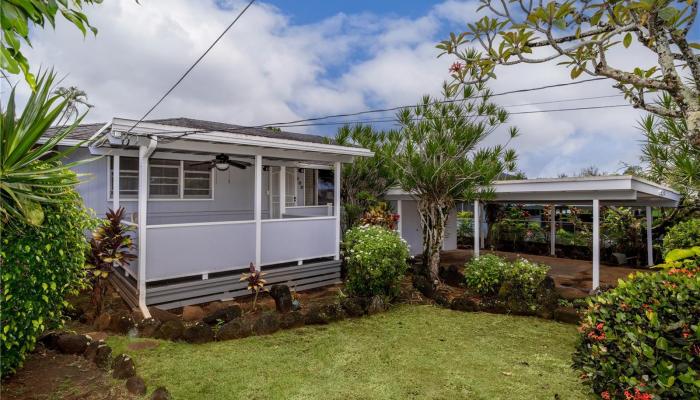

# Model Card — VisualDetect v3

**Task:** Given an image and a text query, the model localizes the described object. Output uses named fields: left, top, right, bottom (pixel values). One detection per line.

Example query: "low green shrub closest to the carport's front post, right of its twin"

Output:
left=498, top=258, right=549, bottom=312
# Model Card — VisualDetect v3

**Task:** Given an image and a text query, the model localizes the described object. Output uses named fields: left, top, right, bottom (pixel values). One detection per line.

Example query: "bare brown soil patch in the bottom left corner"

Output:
left=0, top=350, right=136, bottom=400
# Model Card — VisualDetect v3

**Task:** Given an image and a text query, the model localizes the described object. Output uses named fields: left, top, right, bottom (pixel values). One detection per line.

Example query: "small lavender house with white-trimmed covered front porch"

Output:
left=50, top=118, right=372, bottom=315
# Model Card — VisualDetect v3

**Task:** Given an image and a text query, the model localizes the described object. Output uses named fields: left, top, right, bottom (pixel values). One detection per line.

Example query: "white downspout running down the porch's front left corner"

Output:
left=138, top=138, right=158, bottom=318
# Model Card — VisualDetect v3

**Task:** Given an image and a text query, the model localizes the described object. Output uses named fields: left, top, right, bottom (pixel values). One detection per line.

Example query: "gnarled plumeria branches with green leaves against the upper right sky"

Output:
left=437, top=0, right=700, bottom=146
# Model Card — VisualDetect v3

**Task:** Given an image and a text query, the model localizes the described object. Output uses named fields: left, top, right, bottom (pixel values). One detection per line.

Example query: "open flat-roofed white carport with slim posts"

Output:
left=385, top=175, right=680, bottom=289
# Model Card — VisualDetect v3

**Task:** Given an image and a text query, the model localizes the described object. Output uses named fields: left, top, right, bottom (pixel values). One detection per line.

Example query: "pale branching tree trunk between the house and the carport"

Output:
left=418, top=199, right=451, bottom=282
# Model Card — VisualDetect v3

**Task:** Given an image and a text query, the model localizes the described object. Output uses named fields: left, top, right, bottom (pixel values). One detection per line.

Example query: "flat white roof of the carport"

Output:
left=387, top=175, right=680, bottom=207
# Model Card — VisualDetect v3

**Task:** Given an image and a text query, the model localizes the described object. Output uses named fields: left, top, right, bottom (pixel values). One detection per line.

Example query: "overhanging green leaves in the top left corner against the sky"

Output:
left=0, top=0, right=102, bottom=88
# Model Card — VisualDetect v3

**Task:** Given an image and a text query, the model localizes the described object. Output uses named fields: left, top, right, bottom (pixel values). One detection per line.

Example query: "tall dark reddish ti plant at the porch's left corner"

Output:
left=86, top=207, right=136, bottom=316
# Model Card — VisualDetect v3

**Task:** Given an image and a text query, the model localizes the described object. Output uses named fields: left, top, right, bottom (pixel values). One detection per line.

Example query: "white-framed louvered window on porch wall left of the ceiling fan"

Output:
left=107, top=156, right=214, bottom=200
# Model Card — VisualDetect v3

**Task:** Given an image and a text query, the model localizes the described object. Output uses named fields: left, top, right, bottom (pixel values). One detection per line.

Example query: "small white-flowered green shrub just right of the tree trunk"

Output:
left=464, top=254, right=511, bottom=296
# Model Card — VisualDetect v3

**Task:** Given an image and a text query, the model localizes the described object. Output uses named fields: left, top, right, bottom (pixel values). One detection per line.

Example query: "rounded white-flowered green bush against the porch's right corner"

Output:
left=343, top=225, right=409, bottom=296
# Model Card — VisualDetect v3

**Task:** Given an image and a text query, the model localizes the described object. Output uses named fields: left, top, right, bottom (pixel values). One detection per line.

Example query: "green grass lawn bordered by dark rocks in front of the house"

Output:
left=108, top=306, right=586, bottom=400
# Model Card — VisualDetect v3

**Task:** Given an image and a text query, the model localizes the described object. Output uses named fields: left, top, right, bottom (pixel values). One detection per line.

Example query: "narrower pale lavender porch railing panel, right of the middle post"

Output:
left=262, top=217, right=337, bottom=265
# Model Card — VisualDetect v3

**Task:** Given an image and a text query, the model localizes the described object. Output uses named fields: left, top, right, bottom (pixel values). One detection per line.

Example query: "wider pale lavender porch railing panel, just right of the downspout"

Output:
left=146, top=221, right=255, bottom=281
